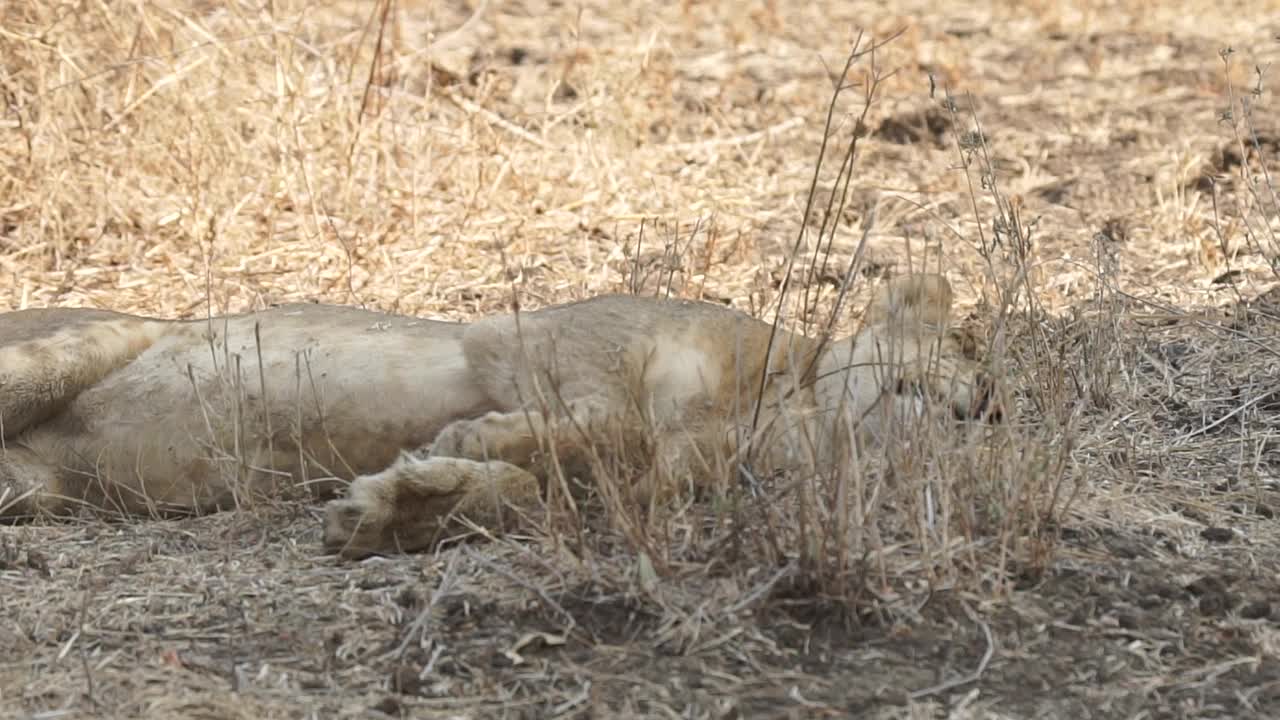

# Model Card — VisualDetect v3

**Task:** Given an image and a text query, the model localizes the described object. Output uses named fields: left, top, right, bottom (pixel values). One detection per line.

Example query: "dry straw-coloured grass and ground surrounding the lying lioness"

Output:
left=0, top=0, right=1280, bottom=717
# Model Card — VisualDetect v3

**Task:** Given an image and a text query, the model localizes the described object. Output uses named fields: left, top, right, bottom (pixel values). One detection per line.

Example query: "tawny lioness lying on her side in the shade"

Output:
left=0, top=274, right=989, bottom=557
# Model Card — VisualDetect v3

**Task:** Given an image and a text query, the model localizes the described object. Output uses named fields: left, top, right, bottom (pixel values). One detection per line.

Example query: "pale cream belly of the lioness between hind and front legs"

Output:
left=31, top=307, right=492, bottom=511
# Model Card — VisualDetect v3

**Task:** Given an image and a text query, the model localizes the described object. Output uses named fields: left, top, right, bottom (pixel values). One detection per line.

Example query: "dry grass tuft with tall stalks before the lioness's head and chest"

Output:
left=506, top=36, right=1114, bottom=614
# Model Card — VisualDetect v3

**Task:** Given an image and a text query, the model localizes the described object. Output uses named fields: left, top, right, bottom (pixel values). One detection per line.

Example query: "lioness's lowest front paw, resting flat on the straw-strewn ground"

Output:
left=324, top=455, right=539, bottom=559
